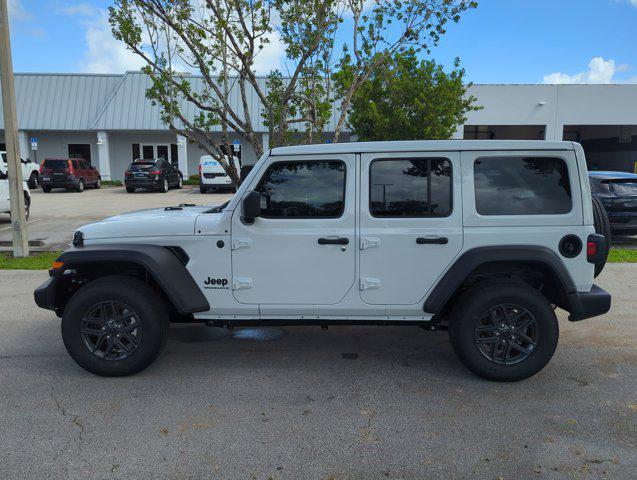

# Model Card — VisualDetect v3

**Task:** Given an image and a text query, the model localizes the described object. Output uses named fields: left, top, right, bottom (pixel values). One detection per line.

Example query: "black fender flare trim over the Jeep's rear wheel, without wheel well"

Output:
left=424, top=245, right=577, bottom=314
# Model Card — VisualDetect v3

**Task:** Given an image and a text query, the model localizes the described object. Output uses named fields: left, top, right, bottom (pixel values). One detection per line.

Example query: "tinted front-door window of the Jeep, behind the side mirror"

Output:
left=257, top=160, right=345, bottom=218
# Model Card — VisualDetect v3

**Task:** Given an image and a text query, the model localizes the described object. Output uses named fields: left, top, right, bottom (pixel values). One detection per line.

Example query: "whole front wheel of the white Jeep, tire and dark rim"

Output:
left=62, top=276, right=168, bottom=377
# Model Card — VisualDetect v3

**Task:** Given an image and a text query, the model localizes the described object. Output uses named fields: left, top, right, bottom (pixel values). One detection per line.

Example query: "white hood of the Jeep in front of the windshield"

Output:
left=79, top=206, right=211, bottom=240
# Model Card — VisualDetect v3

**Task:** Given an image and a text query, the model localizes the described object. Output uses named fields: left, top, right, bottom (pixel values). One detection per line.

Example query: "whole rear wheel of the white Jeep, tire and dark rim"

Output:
left=449, top=282, right=559, bottom=382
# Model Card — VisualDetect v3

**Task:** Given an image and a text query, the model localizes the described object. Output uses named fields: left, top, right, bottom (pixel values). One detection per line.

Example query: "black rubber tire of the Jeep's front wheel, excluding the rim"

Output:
left=62, top=276, right=169, bottom=377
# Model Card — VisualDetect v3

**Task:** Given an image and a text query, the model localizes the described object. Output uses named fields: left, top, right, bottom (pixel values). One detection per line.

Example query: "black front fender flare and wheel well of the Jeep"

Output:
left=43, top=244, right=210, bottom=315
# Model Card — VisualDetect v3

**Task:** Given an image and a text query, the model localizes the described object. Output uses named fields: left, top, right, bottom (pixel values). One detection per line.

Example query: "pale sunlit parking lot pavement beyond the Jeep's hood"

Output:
left=0, top=186, right=232, bottom=250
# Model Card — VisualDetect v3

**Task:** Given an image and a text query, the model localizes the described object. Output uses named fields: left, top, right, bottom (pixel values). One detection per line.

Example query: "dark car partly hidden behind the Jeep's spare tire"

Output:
left=588, top=172, right=637, bottom=235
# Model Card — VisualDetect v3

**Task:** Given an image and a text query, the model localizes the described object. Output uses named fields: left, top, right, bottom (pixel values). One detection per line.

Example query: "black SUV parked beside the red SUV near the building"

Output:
left=124, top=158, right=184, bottom=193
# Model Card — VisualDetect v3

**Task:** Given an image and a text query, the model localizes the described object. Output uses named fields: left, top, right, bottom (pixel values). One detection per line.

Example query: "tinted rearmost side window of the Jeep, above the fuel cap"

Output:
left=474, top=157, right=572, bottom=215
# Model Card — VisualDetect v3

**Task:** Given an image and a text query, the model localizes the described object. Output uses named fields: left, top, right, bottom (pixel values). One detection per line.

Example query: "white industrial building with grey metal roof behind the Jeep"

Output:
left=0, top=72, right=637, bottom=180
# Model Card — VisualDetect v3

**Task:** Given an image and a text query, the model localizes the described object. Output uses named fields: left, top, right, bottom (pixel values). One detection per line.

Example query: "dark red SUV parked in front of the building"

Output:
left=40, top=158, right=102, bottom=193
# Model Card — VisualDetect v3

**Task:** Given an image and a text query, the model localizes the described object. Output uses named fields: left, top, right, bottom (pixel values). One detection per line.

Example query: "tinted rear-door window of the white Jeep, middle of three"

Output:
left=369, top=158, right=451, bottom=217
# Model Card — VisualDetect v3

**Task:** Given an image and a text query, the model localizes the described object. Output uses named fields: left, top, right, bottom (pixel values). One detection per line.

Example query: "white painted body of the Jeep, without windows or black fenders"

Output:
left=81, top=141, right=594, bottom=320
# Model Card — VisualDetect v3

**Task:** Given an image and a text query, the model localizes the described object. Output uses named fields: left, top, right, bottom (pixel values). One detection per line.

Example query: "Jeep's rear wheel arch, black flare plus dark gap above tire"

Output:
left=423, top=245, right=577, bottom=314
